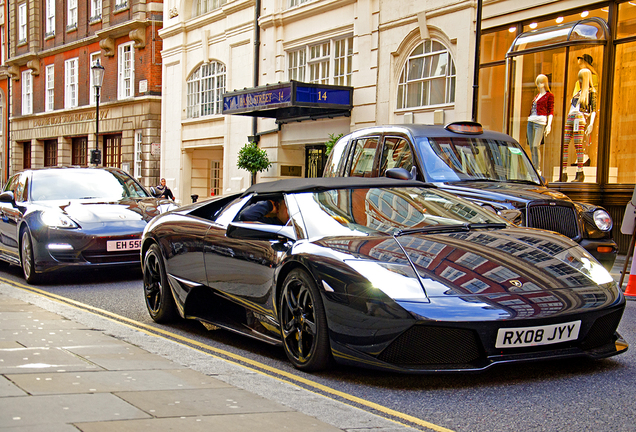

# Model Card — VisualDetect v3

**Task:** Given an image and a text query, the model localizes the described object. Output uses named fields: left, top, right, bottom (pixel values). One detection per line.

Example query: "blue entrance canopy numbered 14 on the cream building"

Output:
left=223, top=80, right=353, bottom=123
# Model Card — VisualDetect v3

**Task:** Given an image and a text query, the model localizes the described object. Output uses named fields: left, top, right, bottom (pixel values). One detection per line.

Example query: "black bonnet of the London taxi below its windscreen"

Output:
left=435, top=181, right=571, bottom=205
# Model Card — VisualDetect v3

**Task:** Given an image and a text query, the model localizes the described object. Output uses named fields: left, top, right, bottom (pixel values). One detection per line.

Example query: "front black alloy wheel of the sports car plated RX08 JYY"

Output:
left=278, top=269, right=331, bottom=371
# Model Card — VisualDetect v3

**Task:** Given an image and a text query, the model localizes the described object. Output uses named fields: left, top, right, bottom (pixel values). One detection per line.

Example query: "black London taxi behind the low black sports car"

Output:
left=323, top=122, right=618, bottom=269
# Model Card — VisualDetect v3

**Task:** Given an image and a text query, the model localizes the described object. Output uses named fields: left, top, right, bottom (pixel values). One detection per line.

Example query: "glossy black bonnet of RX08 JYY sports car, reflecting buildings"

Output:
left=314, top=228, right=621, bottom=321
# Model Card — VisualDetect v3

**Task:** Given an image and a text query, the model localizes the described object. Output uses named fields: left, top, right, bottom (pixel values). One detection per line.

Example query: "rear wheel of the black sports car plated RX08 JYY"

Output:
left=143, top=244, right=177, bottom=323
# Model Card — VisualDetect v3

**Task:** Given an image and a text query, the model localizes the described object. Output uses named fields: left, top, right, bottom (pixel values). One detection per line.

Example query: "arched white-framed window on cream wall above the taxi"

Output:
left=397, top=40, right=456, bottom=109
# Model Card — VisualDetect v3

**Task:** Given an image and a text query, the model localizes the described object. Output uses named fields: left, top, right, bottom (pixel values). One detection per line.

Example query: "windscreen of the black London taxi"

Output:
left=416, top=137, right=541, bottom=184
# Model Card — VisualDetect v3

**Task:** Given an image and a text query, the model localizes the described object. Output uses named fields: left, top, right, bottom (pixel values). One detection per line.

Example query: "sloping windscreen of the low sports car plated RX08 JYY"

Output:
left=295, top=187, right=508, bottom=237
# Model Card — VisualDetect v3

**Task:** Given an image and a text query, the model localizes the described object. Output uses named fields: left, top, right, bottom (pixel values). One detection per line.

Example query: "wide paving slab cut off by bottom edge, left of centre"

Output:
left=75, top=412, right=342, bottom=432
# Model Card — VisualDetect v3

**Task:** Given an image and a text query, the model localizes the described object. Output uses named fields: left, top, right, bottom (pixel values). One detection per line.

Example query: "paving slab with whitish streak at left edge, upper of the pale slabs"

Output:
left=0, top=347, right=101, bottom=374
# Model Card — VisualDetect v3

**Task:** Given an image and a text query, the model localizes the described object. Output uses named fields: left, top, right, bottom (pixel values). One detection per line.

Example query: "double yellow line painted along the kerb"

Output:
left=0, top=277, right=453, bottom=432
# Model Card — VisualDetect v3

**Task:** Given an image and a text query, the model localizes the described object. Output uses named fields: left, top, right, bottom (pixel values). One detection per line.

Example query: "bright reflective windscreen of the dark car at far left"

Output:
left=31, top=168, right=149, bottom=201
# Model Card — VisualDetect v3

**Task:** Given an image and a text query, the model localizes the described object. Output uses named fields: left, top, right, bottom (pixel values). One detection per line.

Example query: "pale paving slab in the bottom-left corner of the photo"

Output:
left=0, top=393, right=150, bottom=428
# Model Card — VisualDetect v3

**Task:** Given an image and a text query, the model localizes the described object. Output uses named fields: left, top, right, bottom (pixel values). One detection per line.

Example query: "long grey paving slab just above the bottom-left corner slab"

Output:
left=6, top=369, right=230, bottom=395
